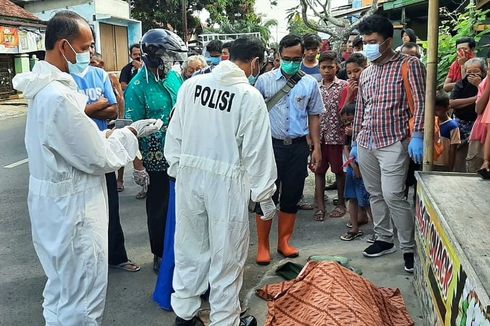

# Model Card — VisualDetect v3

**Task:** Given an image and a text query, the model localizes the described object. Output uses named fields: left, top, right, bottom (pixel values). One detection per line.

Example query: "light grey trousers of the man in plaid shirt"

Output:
left=358, top=140, right=415, bottom=253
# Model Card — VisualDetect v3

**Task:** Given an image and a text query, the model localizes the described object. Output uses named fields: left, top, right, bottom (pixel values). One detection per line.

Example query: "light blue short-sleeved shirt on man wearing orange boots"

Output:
left=255, top=69, right=324, bottom=140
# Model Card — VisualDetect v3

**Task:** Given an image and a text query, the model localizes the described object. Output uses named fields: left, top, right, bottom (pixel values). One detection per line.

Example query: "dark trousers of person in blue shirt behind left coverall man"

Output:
left=105, top=172, right=128, bottom=265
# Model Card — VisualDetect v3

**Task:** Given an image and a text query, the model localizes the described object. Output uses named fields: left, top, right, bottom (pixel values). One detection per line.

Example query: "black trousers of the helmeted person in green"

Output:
left=146, top=171, right=170, bottom=258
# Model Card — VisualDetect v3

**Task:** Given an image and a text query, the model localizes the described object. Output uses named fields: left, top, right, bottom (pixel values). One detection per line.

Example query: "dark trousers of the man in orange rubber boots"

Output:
left=256, top=140, right=310, bottom=214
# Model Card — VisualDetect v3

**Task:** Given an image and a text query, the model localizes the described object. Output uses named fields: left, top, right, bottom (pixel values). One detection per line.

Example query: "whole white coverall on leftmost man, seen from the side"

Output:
left=13, top=61, right=138, bottom=326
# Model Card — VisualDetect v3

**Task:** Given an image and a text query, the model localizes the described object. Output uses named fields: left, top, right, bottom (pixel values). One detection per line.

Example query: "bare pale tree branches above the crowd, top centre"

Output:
left=290, top=0, right=378, bottom=49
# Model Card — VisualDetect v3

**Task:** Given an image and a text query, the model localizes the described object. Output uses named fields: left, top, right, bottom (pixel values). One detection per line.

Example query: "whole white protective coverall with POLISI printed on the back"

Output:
left=165, top=61, right=277, bottom=326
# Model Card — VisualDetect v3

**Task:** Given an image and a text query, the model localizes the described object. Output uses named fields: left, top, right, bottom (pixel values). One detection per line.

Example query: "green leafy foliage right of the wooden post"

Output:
left=423, top=5, right=490, bottom=87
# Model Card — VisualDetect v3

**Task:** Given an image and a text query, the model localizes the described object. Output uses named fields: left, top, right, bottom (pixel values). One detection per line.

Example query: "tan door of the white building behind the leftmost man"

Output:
left=99, top=23, right=129, bottom=71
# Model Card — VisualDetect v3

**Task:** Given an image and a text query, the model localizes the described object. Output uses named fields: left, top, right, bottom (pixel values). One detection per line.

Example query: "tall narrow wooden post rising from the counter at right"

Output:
left=423, top=0, right=439, bottom=171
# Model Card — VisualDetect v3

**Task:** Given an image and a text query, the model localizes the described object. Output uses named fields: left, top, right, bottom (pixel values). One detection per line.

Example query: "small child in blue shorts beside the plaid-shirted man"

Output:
left=340, top=103, right=370, bottom=241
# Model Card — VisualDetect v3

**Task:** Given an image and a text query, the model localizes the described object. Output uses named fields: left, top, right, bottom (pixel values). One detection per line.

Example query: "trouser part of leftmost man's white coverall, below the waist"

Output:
left=28, top=177, right=108, bottom=326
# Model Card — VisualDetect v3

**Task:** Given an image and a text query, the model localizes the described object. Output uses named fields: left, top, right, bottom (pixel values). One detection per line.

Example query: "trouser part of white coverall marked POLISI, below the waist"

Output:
left=171, top=168, right=249, bottom=326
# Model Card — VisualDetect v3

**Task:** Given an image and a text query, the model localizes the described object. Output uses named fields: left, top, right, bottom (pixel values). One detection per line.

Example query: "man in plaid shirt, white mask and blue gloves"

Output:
left=353, top=15, right=425, bottom=272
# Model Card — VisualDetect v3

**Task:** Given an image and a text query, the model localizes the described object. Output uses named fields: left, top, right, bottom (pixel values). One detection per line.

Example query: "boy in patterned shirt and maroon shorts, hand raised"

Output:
left=313, top=51, right=348, bottom=221
